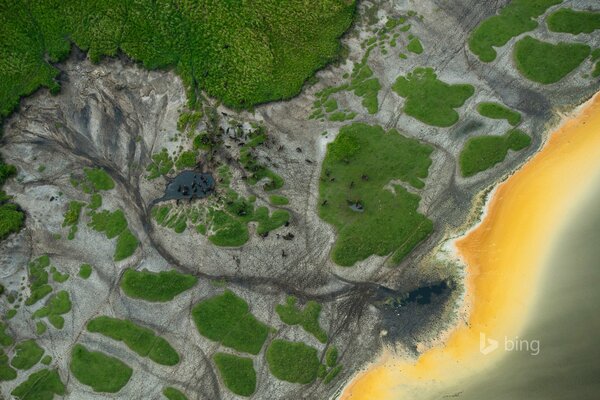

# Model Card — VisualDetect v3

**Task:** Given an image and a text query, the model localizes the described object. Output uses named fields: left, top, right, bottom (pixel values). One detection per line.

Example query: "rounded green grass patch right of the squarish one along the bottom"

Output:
left=267, top=339, right=321, bottom=384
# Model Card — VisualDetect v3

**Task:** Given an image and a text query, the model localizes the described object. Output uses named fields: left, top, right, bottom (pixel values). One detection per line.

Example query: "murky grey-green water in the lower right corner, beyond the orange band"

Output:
left=442, top=179, right=600, bottom=400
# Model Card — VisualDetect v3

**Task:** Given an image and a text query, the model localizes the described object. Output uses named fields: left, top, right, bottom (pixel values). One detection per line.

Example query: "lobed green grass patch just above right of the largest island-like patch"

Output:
left=392, top=68, right=475, bottom=127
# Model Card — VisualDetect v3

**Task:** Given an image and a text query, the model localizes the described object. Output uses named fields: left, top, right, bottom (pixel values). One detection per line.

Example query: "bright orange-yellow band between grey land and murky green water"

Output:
left=341, top=94, right=600, bottom=400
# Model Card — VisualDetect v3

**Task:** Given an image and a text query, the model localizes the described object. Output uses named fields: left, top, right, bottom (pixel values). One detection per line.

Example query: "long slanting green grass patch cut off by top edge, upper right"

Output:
left=469, top=0, right=562, bottom=62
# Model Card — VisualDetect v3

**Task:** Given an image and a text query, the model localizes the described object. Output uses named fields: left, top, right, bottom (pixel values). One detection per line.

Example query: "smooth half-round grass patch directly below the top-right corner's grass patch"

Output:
left=514, top=36, right=591, bottom=85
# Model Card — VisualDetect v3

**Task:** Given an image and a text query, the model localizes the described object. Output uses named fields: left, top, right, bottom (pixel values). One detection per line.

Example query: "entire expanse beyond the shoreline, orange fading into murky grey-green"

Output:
left=341, top=95, right=600, bottom=400
